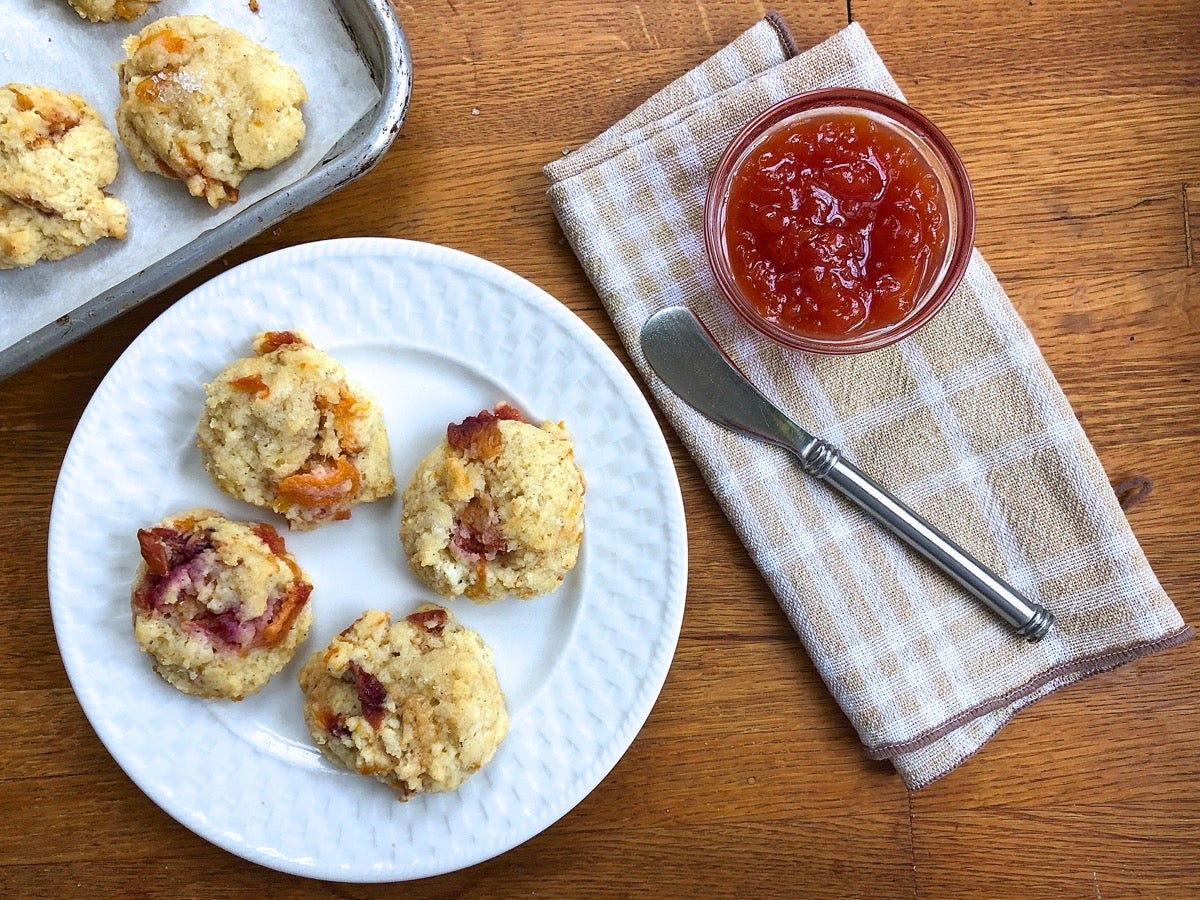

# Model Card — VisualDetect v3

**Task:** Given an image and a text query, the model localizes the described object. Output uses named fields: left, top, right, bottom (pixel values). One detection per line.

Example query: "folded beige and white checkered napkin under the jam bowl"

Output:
left=545, top=14, right=1192, bottom=790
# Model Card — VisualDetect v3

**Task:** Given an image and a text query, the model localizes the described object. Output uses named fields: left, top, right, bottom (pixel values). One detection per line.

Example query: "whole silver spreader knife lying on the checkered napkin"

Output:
left=642, top=306, right=1054, bottom=642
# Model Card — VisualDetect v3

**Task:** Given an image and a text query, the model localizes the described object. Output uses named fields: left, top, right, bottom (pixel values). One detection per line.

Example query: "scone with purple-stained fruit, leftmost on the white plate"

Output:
left=130, top=509, right=312, bottom=700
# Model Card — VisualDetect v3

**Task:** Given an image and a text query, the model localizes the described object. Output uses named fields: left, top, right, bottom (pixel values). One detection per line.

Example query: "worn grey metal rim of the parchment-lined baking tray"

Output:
left=0, top=0, right=413, bottom=380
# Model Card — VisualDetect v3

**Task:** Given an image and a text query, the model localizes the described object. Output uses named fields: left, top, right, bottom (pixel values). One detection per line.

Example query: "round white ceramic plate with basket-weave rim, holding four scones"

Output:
left=49, top=239, right=686, bottom=882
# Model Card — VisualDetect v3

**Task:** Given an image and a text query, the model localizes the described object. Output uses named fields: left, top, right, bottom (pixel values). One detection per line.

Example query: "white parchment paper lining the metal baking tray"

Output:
left=0, top=0, right=379, bottom=349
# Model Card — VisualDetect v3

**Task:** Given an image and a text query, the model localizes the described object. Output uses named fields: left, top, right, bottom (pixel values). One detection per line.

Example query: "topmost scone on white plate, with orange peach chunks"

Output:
left=197, top=331, right=396, bottom=530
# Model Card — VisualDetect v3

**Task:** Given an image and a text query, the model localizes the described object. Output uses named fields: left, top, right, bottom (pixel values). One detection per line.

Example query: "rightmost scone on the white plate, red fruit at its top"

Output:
left=400, top=403, right=586, bottom=602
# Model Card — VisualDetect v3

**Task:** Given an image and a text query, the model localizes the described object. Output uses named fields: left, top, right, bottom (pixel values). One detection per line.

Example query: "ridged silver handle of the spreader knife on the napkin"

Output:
left=797, top=438, right=1054, bottom=643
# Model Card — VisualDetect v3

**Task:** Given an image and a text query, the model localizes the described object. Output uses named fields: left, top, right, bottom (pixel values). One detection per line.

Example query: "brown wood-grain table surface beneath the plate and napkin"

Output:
left=0, top=0, right=1200, bottom=898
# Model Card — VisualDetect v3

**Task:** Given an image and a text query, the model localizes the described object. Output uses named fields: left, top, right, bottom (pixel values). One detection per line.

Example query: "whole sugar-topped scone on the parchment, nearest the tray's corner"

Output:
left=116, top=16, right=308, bottom=208
